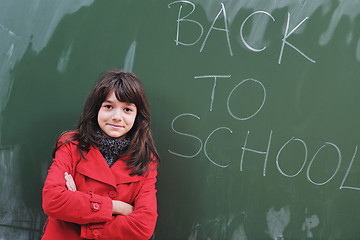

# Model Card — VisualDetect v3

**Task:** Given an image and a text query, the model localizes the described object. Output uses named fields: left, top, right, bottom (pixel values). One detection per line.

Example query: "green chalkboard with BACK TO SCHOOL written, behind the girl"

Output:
left=0, top=0, right=360, bottom=240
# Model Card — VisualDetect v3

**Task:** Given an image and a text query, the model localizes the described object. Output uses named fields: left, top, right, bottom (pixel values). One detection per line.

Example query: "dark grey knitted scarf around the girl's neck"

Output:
left=96, top=131, right=130, bottom=167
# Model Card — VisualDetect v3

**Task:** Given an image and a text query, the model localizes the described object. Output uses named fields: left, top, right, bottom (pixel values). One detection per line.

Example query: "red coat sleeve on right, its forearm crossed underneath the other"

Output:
left=81, top=164, right=158, bottom=240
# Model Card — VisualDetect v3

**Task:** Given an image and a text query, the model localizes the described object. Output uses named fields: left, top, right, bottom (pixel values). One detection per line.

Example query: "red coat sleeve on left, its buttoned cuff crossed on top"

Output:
left=42, top=143, right=112, bottom=224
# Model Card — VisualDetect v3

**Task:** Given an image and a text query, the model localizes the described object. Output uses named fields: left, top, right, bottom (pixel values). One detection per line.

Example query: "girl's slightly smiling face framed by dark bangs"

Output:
left=98, top=91, right=137, bottom=138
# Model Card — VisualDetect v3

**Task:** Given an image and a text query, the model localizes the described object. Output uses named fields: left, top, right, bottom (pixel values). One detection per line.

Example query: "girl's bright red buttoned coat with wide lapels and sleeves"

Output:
left=42, top=136, right=157, bottom=240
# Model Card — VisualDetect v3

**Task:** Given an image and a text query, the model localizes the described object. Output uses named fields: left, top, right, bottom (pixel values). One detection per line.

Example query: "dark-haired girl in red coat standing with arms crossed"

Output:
left=42, top=70, right=159, bottom=240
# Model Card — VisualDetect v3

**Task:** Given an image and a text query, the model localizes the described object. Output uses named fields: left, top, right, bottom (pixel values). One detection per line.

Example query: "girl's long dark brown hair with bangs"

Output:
left=54, top=70, right=160, bottom=176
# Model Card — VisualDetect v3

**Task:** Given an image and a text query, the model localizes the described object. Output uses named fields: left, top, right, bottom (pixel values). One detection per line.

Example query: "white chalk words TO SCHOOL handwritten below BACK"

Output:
left=168, top=72, right=360, bottom=190
